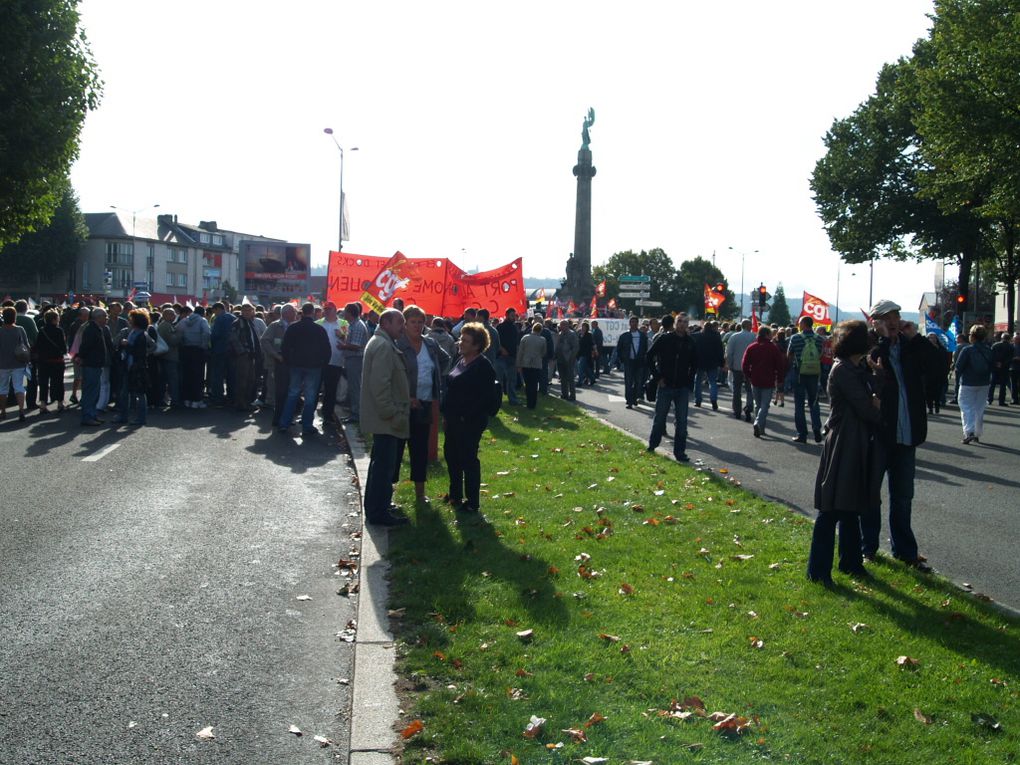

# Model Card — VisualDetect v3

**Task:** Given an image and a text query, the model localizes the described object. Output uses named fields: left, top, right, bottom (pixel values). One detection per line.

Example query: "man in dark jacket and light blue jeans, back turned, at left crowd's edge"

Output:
left=276, top=303, right=333, bottom=436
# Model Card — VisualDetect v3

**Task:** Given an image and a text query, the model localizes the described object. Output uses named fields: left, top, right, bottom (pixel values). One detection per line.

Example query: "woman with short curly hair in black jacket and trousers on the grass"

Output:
left=443, top=321, right=496, bottom=512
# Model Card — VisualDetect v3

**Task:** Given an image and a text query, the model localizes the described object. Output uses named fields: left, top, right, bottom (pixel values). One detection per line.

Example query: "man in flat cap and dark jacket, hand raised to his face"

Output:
left=861, top=300, right=937, bottom=571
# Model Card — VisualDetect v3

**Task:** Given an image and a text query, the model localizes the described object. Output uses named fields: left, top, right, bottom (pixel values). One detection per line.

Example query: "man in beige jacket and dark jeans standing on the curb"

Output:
left=361, top=308, right=411, bottom=526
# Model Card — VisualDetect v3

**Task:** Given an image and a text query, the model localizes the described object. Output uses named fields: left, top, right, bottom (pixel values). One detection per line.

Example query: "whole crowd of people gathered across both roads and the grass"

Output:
left=0, top=300, right=1020, bottom=567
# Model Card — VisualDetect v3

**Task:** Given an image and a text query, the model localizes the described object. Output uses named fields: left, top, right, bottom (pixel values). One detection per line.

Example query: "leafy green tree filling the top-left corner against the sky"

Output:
left=0, top=0, right=102, bottom=247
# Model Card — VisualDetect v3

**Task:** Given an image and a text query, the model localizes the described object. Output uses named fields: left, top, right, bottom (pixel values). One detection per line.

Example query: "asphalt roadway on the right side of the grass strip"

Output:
left=575, top=372, right=1020, bottom=609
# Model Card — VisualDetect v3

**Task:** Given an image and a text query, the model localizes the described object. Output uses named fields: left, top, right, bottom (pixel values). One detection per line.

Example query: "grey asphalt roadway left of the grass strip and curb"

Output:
left=0, top=409, right=360, bottom=765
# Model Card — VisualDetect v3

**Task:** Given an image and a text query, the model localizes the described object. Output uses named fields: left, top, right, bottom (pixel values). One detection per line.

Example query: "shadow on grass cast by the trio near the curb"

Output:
left=388, top=503, right=569, bottom=645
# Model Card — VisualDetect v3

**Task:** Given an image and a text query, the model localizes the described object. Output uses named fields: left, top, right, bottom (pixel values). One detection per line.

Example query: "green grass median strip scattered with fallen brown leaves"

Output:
left=390, top=399, right=1020, bottom=765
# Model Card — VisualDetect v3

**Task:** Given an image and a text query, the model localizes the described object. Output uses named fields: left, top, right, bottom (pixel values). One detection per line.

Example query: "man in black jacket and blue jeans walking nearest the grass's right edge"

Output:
left=648, top=313, right=698, bottom=462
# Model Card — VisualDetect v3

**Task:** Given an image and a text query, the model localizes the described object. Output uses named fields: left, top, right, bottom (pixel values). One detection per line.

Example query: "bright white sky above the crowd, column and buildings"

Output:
left=72, top=0, right=934, bottom=310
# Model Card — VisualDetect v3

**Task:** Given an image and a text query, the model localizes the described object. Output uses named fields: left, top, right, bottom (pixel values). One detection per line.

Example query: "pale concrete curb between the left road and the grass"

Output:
left=344, top=425, right=400, bottom=765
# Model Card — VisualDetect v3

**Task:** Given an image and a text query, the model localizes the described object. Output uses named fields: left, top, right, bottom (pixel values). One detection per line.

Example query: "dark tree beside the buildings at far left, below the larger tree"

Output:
left=0, top=183, right=89, bottom=294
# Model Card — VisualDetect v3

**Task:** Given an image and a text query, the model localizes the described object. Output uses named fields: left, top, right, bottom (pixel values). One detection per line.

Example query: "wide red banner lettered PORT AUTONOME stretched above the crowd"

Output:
left=326, top=252, right=527, bottom=316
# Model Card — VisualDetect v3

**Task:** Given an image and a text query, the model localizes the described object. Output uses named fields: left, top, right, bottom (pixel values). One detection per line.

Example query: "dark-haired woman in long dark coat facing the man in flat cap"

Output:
left=808, top=321, right=882, bottom=587
